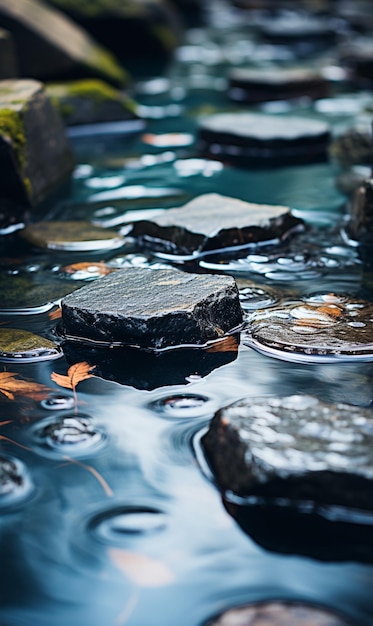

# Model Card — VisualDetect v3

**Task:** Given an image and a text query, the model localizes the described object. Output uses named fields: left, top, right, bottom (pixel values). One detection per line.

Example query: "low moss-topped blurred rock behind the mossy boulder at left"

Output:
left=47, top=79, right=137, bottom=126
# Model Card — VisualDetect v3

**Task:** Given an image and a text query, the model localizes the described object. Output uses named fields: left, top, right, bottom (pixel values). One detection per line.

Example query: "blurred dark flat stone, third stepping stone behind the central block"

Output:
left=228, top=67, right=329, bottom=104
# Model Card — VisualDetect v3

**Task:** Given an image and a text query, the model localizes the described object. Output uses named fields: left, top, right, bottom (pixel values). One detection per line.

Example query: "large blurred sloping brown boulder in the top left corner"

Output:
left=0, top=0, right=127, bottom=86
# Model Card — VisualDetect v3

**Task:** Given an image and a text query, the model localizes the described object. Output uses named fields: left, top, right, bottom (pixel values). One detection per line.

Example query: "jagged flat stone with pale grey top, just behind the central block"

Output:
left=131, top=193, right=303, bottom=256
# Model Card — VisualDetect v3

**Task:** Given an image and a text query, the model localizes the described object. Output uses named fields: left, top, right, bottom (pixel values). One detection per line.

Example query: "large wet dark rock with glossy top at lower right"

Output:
left=202, top=395, right=373, bottom=511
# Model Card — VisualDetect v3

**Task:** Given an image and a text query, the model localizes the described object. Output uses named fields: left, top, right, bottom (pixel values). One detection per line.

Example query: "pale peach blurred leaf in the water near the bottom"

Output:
left=109, top=548, right=174, bottom=587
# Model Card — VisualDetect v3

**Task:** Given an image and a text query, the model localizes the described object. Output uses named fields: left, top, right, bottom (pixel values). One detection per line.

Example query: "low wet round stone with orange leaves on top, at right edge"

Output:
left=244, top=294, right=373, bottom=363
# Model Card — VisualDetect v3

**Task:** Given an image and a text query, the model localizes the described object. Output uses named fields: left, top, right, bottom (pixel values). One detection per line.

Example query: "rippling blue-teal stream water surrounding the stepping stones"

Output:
left=0, top=3, right=373, bottom=626
